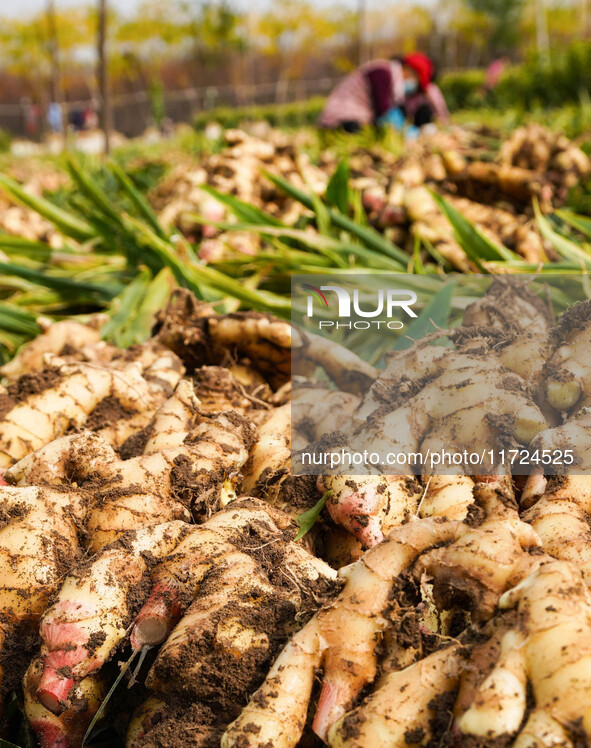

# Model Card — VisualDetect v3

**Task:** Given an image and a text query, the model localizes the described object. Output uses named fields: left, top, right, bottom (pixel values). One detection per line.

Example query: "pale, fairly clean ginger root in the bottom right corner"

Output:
left=456, top=561, right=591, bottom=748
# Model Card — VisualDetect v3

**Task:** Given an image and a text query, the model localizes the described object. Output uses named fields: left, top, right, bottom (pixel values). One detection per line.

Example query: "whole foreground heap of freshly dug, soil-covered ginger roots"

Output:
left=0, top=278, right=591, bottom=748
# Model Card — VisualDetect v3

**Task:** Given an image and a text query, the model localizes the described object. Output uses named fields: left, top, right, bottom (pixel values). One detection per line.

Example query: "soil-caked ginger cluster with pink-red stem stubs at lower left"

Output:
left=29, top=499, right=336, bottom=740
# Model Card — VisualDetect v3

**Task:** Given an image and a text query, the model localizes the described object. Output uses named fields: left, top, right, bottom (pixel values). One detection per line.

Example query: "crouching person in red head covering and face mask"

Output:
left=318, top=52, right=449, bottom=132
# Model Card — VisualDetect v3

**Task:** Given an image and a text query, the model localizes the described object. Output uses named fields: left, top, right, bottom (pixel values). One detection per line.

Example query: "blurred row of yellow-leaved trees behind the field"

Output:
left=0, top=0, right=590, bottom=130
